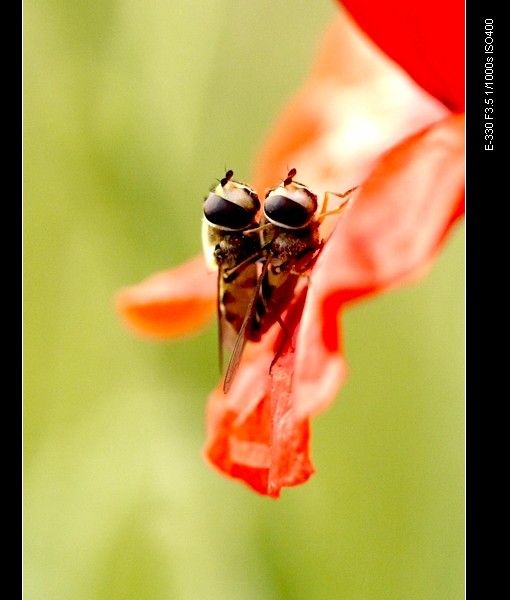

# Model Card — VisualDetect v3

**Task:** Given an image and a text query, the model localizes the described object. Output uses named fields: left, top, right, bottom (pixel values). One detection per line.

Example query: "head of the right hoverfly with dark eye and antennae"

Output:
left=264, top=169, right=317, bottom=229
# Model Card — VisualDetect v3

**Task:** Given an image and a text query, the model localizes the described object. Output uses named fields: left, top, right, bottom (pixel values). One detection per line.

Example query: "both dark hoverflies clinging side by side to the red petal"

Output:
left=202, top=169, right=356, bottom=393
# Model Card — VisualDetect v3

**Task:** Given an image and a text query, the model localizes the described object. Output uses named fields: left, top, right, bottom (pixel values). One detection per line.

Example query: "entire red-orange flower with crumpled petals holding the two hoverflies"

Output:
left=117, top=0, right=464, bottom=497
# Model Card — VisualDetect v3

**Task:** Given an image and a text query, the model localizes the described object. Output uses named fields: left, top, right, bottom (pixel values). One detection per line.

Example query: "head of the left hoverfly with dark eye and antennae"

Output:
left=204, top=171, right=260, bottom=231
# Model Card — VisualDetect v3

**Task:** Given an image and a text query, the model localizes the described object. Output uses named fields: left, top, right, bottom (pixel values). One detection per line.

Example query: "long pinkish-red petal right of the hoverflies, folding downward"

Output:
left=294, top=116, right=464, bottom=416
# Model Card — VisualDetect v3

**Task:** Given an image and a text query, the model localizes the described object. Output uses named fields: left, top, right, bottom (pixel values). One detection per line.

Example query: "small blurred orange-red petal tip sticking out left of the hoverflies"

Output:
left=115, top=256, right=216, bottom=338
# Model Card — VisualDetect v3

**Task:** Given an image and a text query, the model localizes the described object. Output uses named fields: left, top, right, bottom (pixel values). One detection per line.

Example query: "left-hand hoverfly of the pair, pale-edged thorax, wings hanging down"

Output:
left=202, top=170, right=261, bottom=380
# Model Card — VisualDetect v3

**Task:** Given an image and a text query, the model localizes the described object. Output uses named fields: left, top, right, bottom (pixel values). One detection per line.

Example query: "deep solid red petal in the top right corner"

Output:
left=340, top=0, right=465, bottom=111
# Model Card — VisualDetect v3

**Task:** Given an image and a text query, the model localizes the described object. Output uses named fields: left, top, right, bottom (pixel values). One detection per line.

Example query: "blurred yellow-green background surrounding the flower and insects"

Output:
left=24, top=0, right=464, bottom=600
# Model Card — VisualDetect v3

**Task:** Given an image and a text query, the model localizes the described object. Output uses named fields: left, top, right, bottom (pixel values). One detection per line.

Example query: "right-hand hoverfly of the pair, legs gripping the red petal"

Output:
left=223, top=169, right=356, bottom=393
